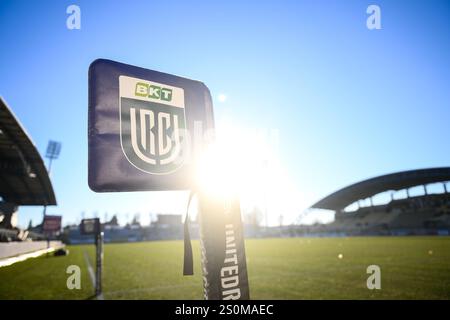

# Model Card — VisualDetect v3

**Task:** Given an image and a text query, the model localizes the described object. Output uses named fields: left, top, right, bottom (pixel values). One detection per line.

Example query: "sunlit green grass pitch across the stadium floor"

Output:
left=0, top=237, right=450, bottom=299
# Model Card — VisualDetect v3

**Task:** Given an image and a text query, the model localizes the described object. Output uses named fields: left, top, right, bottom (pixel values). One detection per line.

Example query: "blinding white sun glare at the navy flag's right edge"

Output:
left=197, top=125, right=299, bottom=225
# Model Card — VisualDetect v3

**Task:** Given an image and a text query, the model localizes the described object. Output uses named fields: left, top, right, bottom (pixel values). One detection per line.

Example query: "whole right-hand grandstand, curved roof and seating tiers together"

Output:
left=311, top=167, right=450, bottom=235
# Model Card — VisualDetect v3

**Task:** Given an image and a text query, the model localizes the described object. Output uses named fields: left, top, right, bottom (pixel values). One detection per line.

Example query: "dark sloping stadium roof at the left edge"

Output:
left=0, top=97, right=56, bottom=205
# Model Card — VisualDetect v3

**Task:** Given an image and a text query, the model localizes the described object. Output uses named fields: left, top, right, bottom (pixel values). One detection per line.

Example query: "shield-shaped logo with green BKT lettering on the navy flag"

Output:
left=119, top=76, right=186, bottom=174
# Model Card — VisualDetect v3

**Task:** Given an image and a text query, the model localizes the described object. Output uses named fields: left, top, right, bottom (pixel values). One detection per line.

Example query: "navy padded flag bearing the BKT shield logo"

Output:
left=87, top=59, right=214, bottom=192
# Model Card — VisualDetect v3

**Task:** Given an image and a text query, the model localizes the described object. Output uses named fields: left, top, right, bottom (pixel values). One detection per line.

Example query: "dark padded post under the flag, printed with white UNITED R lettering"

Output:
left=198, top=193, right=250, bottom=300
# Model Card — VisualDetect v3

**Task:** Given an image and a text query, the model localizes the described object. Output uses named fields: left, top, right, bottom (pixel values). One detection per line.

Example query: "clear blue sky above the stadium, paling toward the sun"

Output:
left=0, top=0, right=450, bottom=226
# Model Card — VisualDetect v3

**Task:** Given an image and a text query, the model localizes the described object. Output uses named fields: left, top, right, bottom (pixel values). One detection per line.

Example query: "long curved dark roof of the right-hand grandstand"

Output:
left=311, top=167, right=450, bottom=211
